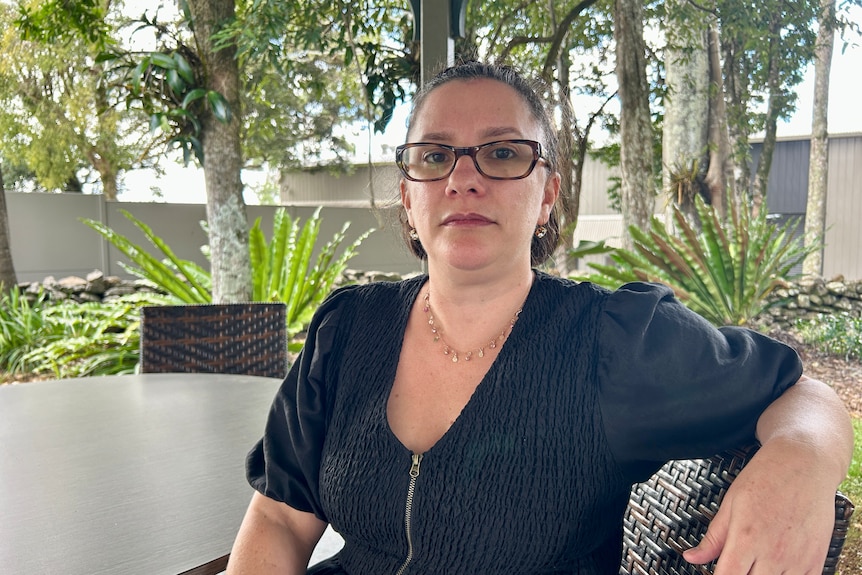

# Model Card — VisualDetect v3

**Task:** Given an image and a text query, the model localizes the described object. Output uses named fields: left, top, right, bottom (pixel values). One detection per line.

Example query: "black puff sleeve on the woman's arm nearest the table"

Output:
left=246, top=288, right=350, bottom=521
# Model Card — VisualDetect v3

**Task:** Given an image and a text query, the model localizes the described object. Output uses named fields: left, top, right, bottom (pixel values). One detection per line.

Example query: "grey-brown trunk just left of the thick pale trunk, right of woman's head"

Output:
left=614, top=0, right=655, bottom=249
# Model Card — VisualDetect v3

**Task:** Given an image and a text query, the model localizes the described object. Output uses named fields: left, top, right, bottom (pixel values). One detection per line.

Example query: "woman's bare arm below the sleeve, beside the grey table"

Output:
left=226, top=493, right=326, bottom=575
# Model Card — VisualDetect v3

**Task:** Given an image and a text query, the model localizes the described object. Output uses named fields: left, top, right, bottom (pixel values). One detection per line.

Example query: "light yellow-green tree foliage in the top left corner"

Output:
left=0, top=0, right=149, bottom=199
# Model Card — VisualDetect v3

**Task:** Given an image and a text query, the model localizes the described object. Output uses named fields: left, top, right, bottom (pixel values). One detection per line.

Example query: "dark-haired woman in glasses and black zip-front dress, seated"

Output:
left=228, top=63, right=852, bottom=575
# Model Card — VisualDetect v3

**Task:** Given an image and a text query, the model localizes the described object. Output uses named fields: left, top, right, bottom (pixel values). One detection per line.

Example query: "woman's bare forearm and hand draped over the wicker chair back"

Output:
left=683, top=377, right=853, bottom=575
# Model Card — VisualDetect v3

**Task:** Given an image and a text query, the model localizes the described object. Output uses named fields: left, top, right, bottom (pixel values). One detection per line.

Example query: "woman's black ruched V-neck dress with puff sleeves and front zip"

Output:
left=248, top=272, right=801, bottom=575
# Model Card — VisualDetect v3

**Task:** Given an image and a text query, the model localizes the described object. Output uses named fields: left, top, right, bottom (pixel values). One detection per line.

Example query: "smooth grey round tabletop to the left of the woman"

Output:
left=0, top=374, right=279, bottom=575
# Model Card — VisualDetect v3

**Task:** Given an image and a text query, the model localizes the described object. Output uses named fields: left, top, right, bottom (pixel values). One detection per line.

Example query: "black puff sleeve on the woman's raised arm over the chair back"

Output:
left=598, top=283, right=802, bottom=481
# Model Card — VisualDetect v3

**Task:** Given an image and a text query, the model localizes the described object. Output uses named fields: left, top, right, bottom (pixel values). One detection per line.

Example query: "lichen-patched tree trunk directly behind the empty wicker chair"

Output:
left=184, top=0, right=252, bottom=302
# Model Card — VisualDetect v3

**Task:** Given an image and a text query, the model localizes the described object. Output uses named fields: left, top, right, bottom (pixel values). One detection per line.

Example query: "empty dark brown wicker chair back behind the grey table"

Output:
left=140, top=303, right=288, bottom=378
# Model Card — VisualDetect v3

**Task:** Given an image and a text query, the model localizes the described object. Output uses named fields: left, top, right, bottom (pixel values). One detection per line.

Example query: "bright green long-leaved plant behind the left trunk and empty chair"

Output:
left=82, top=208, right=372, bottom=336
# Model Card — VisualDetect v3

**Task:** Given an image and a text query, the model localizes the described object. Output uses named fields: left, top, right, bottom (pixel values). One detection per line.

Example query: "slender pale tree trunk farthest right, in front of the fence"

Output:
left=802, top=0, right=835, bottom=276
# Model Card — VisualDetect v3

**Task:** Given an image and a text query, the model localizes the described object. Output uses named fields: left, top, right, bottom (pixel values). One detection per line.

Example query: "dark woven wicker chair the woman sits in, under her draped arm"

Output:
left=620, top=446, right=853, bottom=575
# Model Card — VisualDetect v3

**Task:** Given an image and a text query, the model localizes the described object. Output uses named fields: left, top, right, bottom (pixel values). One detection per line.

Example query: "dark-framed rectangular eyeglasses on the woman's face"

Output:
left=395, top=140, right=542, bottom=182
